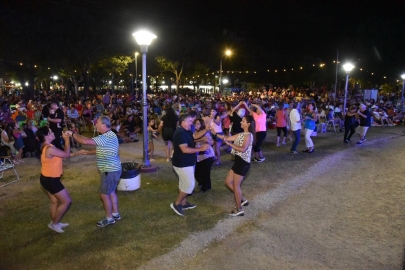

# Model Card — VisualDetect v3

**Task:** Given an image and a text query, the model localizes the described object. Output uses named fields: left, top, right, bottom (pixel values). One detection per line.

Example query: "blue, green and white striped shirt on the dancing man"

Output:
left=93, top=130, right=121, bottom=172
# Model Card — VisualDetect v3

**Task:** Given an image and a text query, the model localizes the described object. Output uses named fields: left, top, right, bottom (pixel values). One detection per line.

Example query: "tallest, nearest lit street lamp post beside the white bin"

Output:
left=132, top=30, right=156, bottom=167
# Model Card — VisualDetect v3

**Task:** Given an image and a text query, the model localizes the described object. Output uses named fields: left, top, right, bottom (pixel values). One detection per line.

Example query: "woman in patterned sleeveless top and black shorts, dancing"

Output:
left=211, top=115, right=256, bottom=217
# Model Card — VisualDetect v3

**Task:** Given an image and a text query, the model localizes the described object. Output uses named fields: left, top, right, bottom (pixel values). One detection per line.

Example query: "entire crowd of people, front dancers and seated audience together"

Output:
left=0, top=86, right=404, bottom=233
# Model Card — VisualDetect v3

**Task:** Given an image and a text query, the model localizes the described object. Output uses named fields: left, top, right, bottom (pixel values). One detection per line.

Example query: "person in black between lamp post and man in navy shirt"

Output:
left=159, top=106, right=179, bottom=162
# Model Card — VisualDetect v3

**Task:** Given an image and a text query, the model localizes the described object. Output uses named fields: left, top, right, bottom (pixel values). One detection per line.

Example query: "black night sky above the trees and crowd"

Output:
left=0, top=0, right=405, bottom=82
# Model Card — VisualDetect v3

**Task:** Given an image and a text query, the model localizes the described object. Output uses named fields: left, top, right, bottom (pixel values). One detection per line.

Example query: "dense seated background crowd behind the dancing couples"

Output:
left=0, top=87, right=404, bottom=164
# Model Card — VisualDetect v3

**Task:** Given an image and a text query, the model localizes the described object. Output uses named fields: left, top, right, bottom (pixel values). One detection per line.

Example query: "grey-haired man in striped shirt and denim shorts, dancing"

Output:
left=67, top=116, right=122, bottom=227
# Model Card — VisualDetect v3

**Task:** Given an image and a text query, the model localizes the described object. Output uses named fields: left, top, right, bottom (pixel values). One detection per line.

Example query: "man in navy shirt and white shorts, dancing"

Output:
left=170, top=114, right=210, bottom=216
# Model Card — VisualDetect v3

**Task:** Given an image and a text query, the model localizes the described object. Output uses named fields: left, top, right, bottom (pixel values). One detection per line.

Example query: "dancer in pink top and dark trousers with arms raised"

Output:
left=244, top=102, right=267, bottom=162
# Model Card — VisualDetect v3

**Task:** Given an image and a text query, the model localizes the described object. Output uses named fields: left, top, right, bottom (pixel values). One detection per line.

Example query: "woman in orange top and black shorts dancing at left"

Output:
left=36, top=126, right=72, bottom=233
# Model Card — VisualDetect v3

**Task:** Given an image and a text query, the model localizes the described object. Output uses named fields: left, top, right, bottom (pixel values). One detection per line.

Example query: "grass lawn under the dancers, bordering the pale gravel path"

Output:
left=0, top=128, right=364, bottom=269
